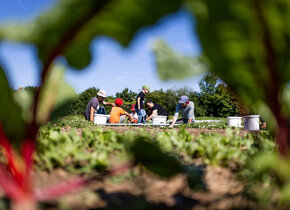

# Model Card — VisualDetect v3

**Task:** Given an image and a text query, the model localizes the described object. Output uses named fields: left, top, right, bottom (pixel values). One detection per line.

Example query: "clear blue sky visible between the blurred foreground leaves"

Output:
left=0, top=0, right=201, bottom=95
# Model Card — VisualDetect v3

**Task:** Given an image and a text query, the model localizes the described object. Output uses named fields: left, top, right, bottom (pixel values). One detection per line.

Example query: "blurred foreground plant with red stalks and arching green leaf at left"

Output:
left=0, top=0, right=184, bottom=209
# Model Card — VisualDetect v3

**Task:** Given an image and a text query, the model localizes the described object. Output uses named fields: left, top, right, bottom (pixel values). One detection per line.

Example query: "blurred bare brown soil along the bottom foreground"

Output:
left=30, top=166, right=256, bottom=210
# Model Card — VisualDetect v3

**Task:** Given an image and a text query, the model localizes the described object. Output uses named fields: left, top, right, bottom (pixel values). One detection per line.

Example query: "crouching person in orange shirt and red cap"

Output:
left=110, top=98, right=133, bottom=124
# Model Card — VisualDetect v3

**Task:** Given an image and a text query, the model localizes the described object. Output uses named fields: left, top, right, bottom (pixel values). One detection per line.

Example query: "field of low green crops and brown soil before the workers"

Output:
left=0, top=116, right=290, bottom=209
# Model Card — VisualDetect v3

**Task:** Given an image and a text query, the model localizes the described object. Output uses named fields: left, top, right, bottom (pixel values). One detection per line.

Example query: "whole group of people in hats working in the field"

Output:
left=85, top=85, right=195, bottom=127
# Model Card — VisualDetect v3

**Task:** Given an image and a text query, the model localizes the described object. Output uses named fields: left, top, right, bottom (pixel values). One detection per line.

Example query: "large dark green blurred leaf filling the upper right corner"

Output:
left=187, top=0, right=290, bottom=132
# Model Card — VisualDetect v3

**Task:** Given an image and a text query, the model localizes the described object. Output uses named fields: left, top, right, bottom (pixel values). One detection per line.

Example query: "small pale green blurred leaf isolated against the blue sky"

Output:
left=153, top=40, right=208, bottom=80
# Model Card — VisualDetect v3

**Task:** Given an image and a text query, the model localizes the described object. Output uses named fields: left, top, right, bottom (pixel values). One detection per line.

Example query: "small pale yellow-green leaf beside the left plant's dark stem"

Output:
left=37, top=65, right=76, bottom=124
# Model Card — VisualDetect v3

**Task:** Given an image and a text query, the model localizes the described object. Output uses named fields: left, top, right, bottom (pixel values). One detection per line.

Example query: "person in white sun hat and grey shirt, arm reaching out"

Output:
left=85, top=90, right=115, bottom=122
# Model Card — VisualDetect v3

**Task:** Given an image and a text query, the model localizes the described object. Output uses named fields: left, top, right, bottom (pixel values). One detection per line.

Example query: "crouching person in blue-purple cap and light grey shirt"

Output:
left=170, top=95, right=194, bottom=127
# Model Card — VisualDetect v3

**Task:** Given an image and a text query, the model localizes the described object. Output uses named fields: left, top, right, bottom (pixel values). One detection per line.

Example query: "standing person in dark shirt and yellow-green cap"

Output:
left=135, top=85, right=150, bottom=123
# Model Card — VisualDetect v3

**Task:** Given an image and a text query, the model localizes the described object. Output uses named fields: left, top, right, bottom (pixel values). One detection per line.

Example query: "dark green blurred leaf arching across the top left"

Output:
left=0, top=0, right=181, bottom=69
